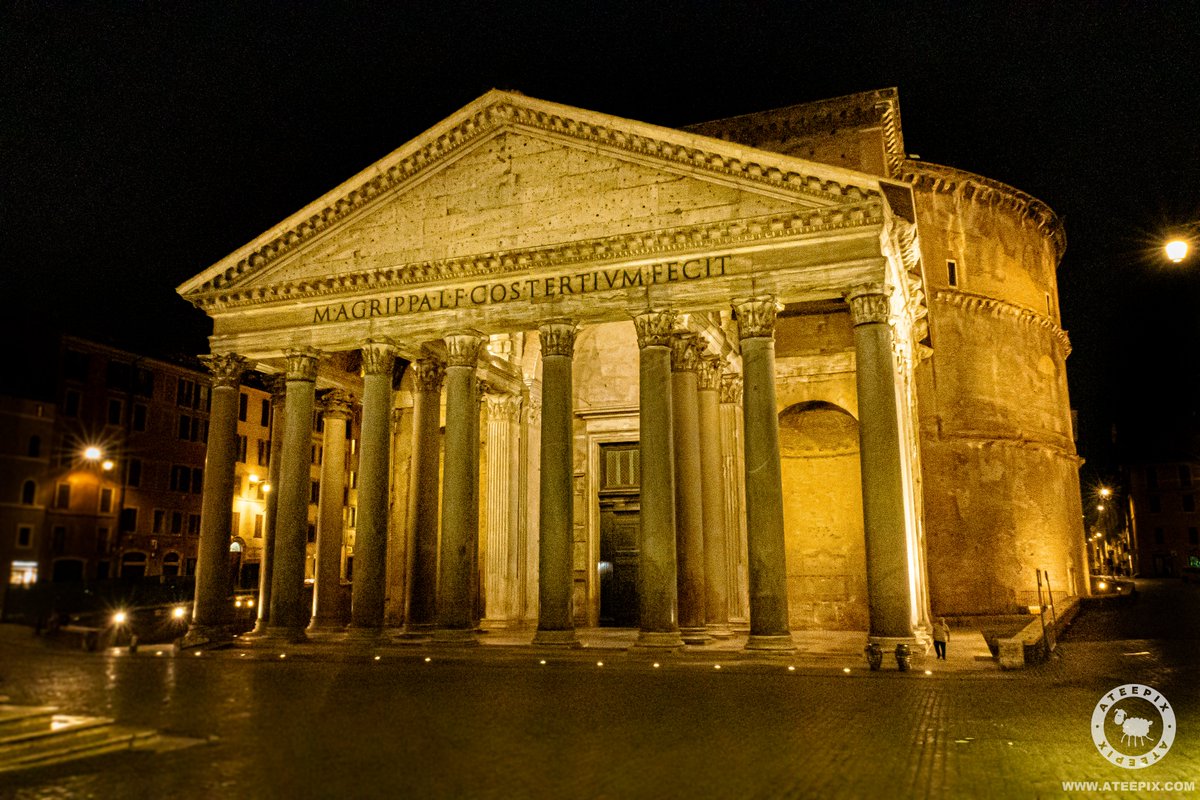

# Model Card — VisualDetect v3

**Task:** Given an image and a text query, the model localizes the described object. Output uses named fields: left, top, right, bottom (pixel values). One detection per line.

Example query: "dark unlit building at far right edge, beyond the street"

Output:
left=1127, top=452, right=1200, bottom=577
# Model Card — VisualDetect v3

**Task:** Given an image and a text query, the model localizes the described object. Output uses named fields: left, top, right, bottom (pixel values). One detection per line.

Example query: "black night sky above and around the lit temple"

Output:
left=0, top=0, right=1200, bottom=467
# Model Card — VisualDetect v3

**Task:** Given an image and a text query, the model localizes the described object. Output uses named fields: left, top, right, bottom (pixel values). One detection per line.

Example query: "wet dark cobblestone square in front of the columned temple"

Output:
left=0, top=582, right=1200, bottom=799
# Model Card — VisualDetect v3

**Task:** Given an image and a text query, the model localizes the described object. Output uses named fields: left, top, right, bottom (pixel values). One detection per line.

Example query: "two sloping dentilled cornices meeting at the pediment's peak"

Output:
left=178, top=91, right=878, bottom=305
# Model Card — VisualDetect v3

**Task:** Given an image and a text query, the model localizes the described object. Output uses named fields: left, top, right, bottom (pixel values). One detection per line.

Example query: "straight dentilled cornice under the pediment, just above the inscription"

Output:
left=188, top=199, right=884, bottom=311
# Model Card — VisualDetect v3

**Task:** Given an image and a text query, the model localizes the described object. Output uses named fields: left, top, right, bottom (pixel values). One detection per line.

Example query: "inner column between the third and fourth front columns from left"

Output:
left=404, top=356, right=445, bottom=636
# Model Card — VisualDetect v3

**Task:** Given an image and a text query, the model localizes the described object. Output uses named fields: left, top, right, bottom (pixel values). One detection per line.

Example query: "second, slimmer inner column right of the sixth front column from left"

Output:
left=700, top=354, right=730, bottom=638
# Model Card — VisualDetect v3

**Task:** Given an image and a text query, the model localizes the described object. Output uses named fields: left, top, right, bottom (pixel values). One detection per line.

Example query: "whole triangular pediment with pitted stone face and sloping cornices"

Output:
left=179, top=91, right=878, bottom=300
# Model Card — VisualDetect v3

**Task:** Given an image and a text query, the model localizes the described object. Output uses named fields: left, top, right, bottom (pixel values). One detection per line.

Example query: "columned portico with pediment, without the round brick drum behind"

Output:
left=179, top=91, right=928, bottom=651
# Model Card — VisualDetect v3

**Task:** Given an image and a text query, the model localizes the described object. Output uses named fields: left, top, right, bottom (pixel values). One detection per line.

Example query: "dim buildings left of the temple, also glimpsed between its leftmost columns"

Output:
left=0, top=337, right=350, bottom=618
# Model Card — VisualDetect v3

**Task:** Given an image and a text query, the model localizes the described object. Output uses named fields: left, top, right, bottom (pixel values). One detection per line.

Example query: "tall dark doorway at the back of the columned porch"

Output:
left=599, top=441, right=641, bottom=627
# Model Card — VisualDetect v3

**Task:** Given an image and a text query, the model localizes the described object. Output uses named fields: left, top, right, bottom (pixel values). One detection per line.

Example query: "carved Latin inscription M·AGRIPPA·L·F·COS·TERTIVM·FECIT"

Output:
left=312, top=255, right=730, bottom=323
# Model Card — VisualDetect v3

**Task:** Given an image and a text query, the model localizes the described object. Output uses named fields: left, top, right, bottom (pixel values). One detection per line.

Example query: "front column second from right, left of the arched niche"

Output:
left=733, top=296, right=796, bottom=650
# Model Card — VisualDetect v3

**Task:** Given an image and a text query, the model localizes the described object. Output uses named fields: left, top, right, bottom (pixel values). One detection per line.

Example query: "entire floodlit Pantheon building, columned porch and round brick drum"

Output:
left=179, top=90, right=1087, bottom=650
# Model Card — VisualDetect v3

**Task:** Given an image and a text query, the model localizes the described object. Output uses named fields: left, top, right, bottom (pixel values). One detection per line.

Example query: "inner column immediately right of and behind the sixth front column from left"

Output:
left=671, top=333, right=709, bottom=644
